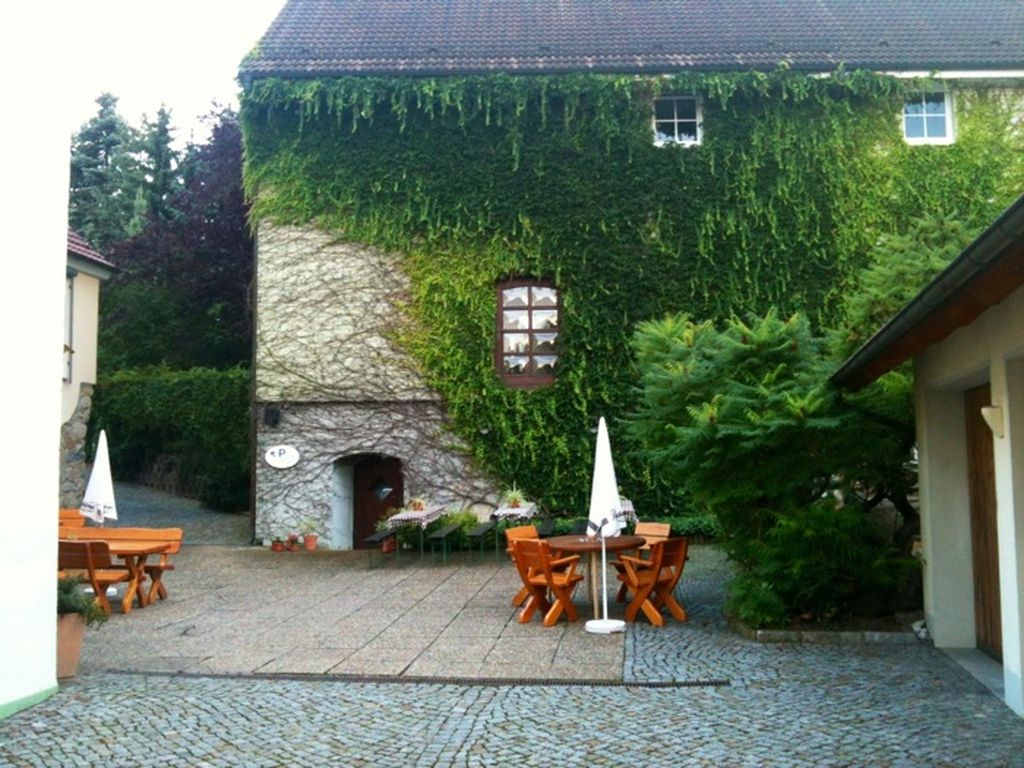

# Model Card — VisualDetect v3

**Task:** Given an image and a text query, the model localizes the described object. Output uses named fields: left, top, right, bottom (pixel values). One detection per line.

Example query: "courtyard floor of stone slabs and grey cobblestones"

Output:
left=9, top=489, right=1024, bottom=768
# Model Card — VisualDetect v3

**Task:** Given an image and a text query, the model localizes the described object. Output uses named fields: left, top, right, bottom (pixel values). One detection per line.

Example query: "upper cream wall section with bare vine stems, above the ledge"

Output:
left=256, top=224, right=434, bottom=402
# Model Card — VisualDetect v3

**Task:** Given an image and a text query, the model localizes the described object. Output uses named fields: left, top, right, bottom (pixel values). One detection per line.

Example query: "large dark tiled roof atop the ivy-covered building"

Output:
left=241, top=0, right=1024, bottom=79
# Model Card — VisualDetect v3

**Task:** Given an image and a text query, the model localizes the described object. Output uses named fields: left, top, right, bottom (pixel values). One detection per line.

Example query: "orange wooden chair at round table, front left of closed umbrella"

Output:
left=512, top=539, right=583, bottom=627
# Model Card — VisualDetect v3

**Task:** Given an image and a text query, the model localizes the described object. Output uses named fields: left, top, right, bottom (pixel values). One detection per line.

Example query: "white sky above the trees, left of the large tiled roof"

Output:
left=61, top=0, right=285, bottom=146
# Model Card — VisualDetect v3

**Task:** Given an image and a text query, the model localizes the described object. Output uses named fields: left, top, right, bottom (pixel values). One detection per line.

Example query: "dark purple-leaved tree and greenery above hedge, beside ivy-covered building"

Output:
left=99, top=111, right=252, bottom=370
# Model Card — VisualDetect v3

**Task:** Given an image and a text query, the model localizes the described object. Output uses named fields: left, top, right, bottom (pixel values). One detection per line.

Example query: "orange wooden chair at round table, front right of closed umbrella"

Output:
left=617, top=537, right=689, bottom=627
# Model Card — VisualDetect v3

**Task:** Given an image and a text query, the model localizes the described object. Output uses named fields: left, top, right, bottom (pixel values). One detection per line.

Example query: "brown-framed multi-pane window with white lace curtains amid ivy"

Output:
left=495, top=279, right=561, bottom=389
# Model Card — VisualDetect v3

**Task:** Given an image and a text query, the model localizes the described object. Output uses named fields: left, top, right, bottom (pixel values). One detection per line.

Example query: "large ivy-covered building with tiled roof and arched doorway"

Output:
left=241, top=0, right=1024, bottom=548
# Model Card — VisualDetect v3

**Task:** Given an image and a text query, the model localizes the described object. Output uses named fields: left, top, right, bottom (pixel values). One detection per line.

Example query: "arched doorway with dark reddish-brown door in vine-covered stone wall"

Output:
left=331, top=454, right=406, bottom=549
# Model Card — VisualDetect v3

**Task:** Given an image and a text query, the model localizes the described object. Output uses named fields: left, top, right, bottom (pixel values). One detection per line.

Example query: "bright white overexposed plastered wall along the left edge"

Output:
left=0, top=3, right=67, bottom=717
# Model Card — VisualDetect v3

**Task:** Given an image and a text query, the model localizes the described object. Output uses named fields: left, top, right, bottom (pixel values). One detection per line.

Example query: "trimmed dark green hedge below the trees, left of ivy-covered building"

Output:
left=91, top=368, right=251, bottom=512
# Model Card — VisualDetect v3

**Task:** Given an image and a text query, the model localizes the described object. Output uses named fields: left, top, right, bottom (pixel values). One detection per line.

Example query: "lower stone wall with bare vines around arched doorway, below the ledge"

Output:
left=255, top=401, right=497, bottom=545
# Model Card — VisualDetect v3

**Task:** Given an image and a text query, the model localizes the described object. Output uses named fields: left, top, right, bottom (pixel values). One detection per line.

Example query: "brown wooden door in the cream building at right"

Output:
left=964, top=384, right=1002, bottom=662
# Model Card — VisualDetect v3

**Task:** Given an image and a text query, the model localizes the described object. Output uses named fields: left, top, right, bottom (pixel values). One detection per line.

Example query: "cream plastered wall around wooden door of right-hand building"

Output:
left=914, top=289, right=1024, bottom=715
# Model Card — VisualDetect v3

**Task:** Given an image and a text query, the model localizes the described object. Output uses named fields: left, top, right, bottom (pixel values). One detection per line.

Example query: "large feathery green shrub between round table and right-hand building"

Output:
left=630, top=312, right=915, bottom=626
